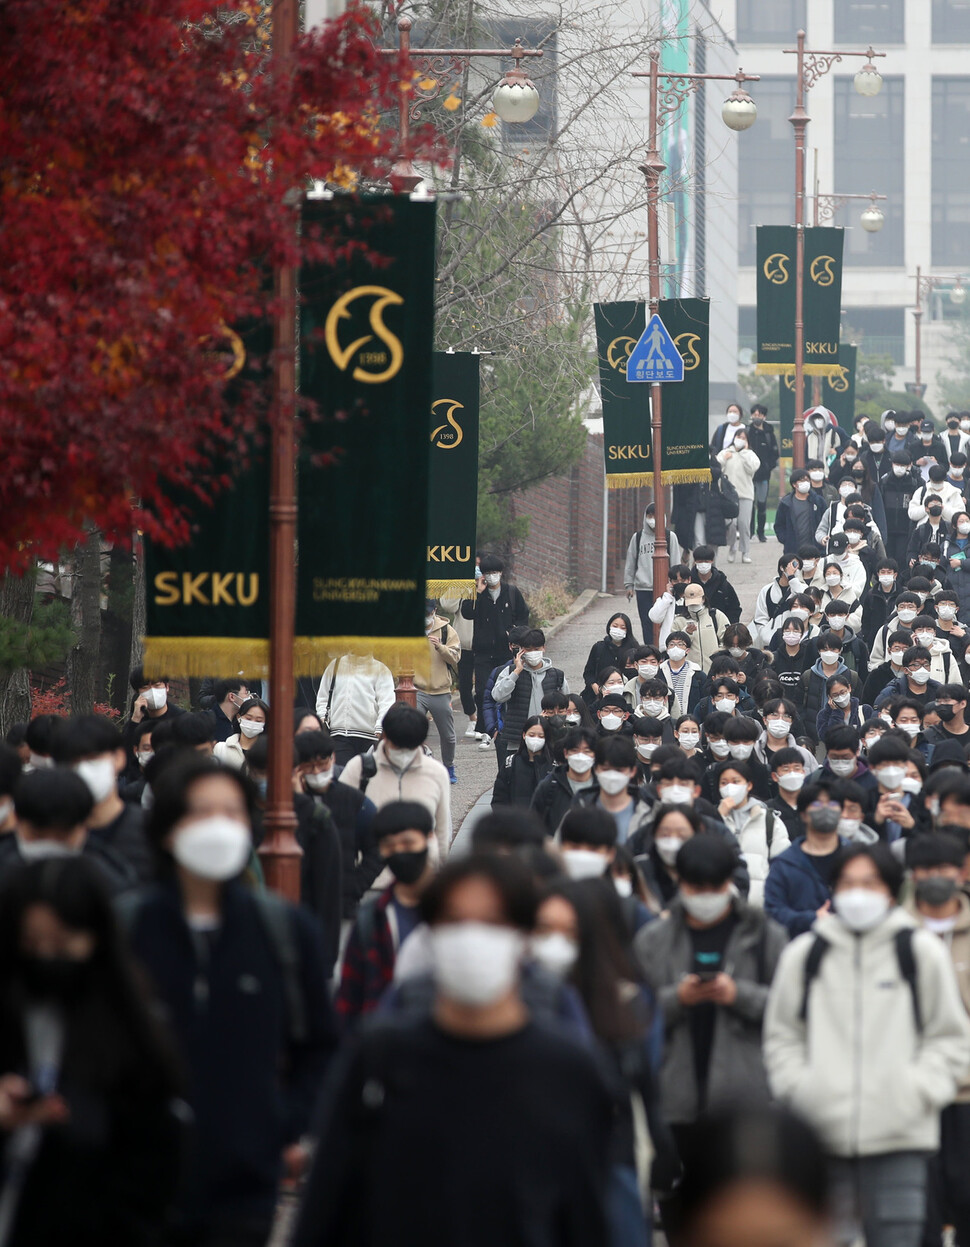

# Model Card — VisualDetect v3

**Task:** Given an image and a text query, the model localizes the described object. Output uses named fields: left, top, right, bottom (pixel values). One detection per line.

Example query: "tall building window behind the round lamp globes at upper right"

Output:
left=822, top=75, right=905, bottom=267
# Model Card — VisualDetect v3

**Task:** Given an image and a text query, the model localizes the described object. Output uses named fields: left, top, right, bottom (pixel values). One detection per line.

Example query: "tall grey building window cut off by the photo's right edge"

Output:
left=931, top=77, right=970, bottom=267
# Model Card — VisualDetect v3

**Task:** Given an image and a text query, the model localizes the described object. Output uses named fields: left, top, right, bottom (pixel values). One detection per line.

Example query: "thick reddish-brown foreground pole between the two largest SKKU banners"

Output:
left=259, top=0, right=303, bottom=904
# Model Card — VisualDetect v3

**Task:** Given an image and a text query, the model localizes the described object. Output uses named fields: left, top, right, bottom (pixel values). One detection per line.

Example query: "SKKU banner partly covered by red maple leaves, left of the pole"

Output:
left=145, top=316, right=272, bottom=677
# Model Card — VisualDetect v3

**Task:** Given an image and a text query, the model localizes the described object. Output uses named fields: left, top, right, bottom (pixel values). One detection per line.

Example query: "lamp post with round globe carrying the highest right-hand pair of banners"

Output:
left=784, top=30, right=885, bottom=468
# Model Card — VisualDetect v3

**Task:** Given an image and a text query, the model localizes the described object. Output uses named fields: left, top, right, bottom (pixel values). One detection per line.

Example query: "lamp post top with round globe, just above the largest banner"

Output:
left=382, top=16, right=542, bottom=193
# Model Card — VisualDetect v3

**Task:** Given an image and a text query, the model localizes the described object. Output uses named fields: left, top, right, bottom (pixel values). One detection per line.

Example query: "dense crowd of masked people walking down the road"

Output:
left=0, top=408, right=970, bottom=1247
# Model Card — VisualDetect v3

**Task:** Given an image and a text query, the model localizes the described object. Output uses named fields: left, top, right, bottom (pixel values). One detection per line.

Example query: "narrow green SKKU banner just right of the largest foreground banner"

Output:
left=426, top=350, right=481, bottom=597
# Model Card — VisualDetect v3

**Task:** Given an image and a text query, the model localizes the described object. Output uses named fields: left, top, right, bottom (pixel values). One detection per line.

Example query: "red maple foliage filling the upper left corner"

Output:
left=0, top=0, right=426, bottom=569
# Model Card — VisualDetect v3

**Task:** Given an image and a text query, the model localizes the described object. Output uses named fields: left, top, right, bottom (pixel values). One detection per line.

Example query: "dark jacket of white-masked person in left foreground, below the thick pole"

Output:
left=130, top=882, right=337, bottom=1237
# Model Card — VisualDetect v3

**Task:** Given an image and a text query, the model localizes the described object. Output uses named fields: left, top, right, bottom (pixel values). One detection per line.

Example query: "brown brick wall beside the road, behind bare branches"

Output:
left=510, top=434, right=652, bottom=592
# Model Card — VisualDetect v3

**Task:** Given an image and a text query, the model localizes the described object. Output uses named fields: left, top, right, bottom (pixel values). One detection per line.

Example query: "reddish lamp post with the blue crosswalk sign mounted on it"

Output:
left=633, top=47, right=759, bottom=618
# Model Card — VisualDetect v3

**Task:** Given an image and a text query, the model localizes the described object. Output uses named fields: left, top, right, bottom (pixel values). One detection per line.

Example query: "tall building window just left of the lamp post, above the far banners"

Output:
left=738, top=77, right=795, bottom=264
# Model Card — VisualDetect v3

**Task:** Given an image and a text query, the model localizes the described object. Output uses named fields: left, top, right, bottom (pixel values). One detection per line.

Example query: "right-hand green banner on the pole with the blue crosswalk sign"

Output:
left=645, top=299, right=711, bottom=485
